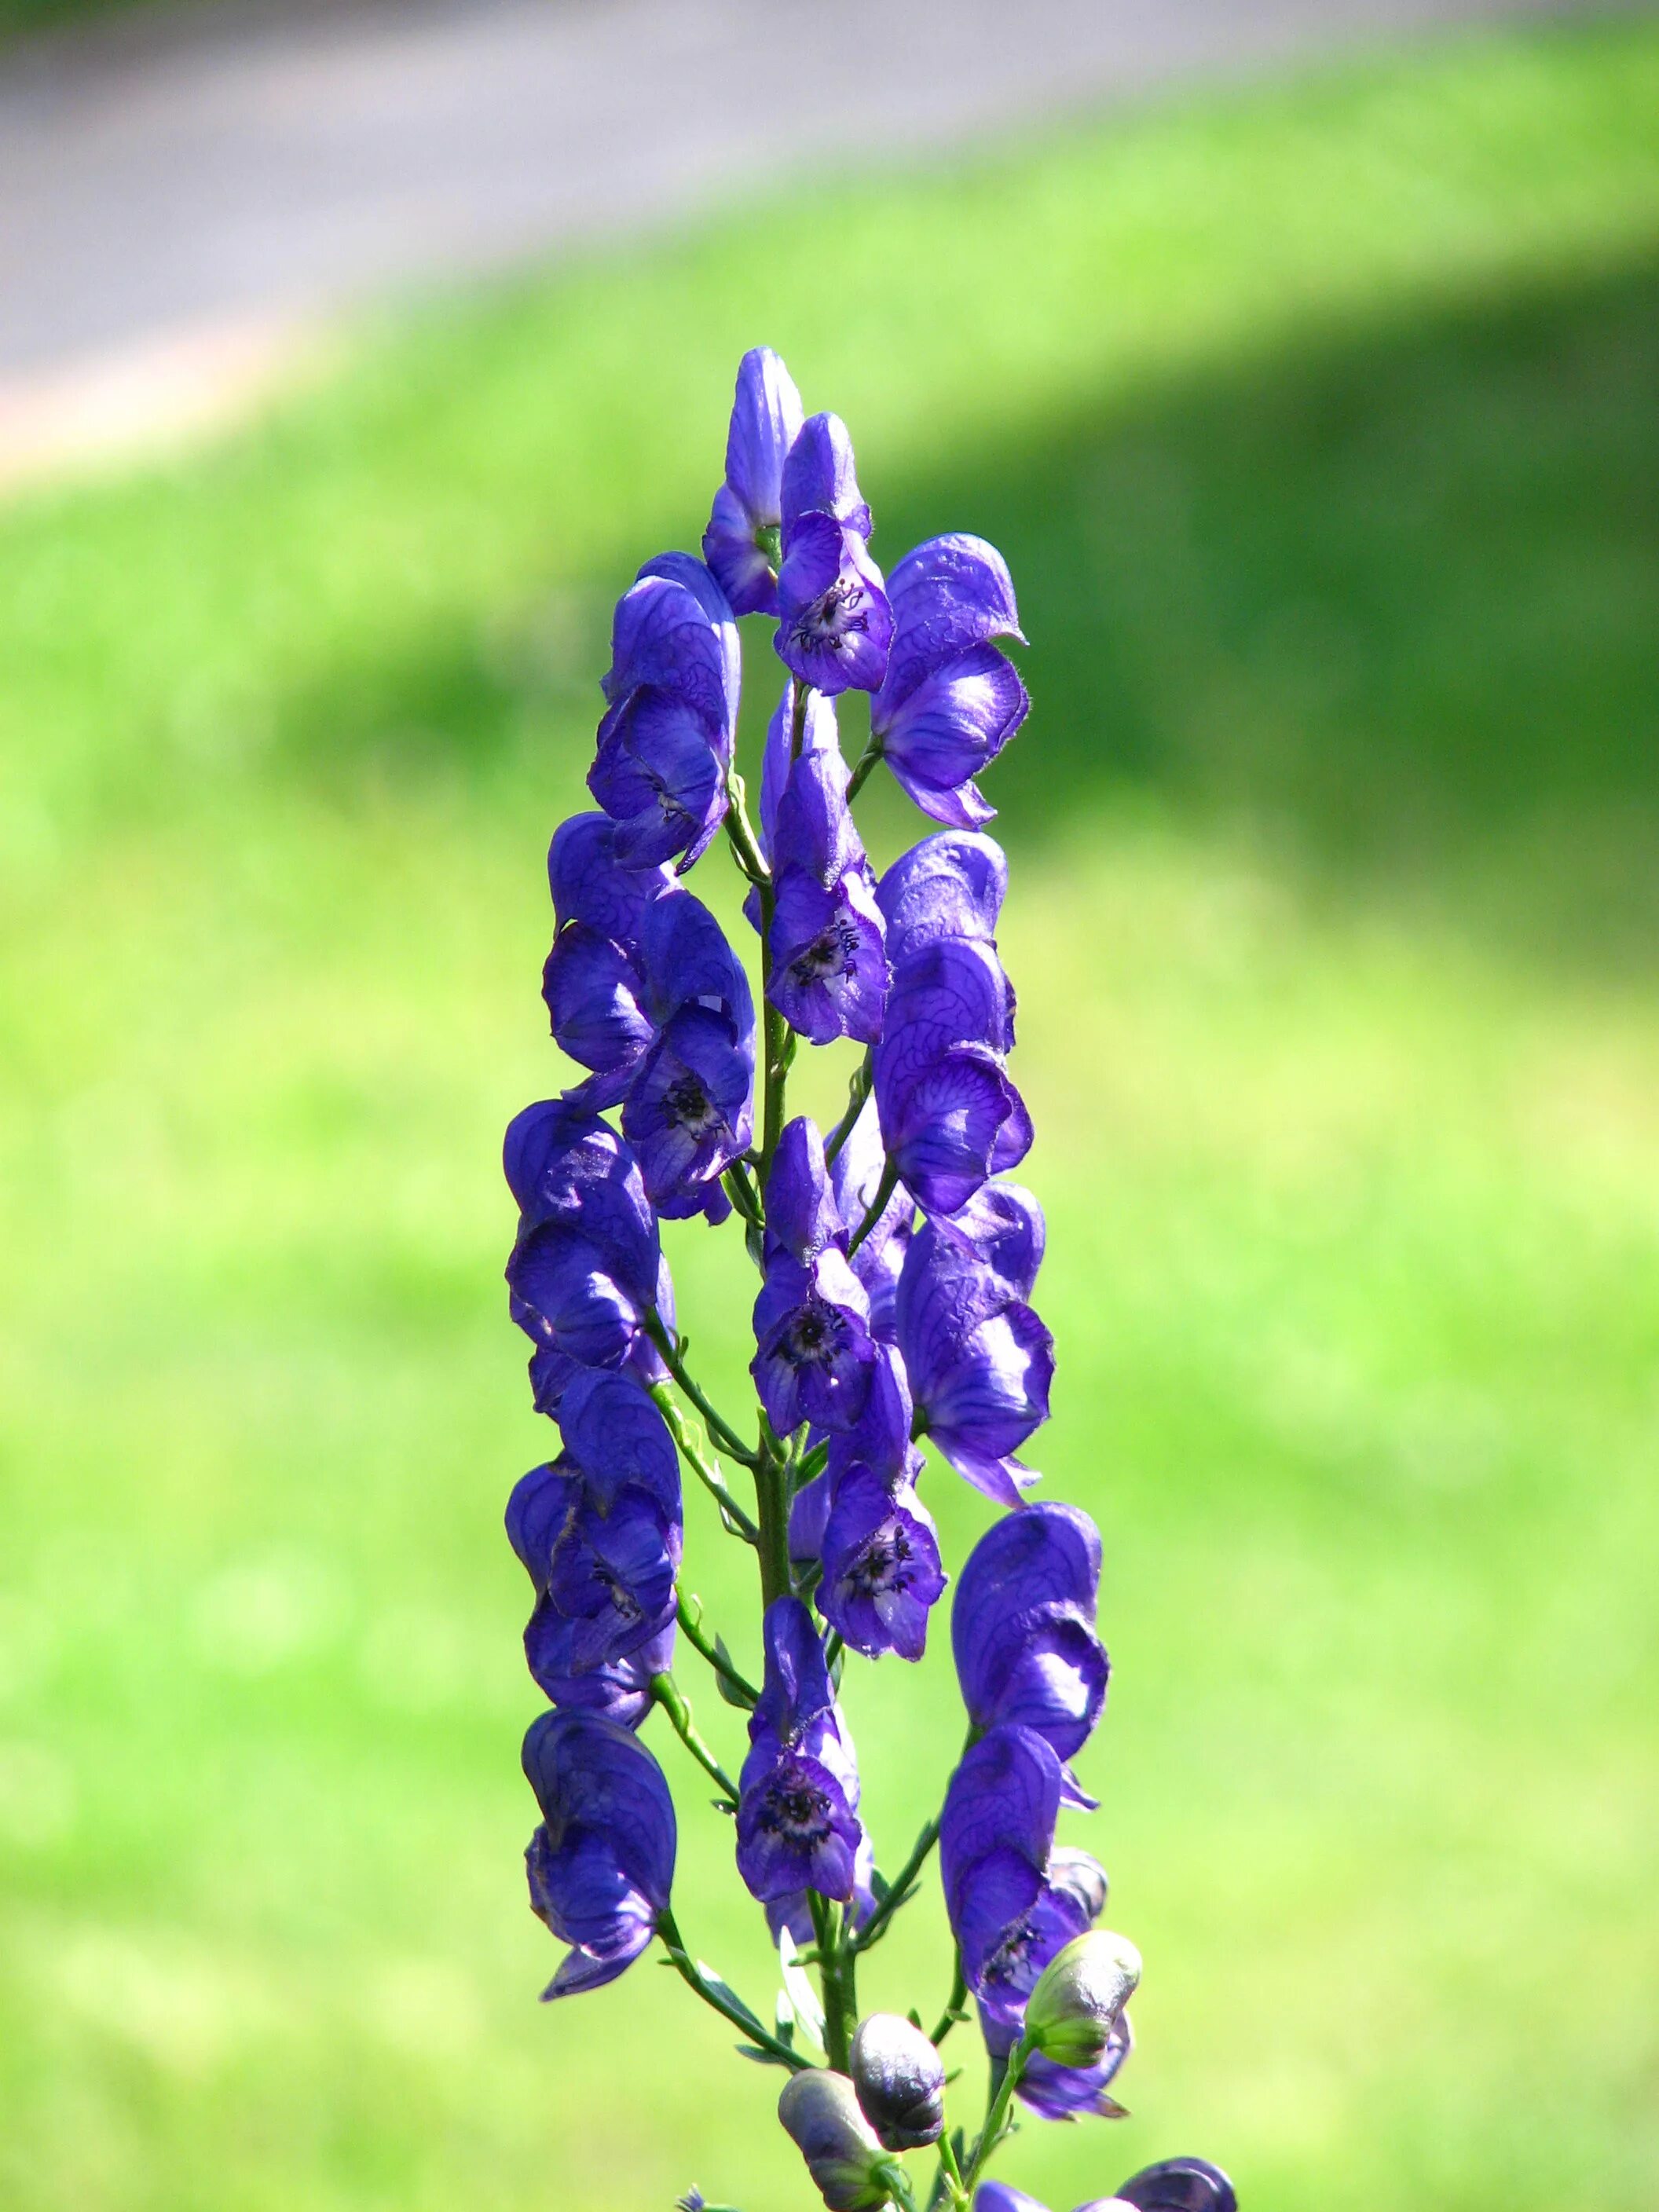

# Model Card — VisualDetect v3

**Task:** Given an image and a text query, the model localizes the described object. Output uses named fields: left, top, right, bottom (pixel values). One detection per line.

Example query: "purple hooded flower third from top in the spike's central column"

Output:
left=750, top=1117, right=876, bottom=1436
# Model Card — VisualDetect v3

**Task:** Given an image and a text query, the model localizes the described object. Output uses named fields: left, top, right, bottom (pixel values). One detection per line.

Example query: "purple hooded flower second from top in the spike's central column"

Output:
left=765, top=716, right=887, bottom=1044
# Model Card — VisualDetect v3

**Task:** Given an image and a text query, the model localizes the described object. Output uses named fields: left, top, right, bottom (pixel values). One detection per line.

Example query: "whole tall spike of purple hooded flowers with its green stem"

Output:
left=504, top=350, right=1238, bottom=2207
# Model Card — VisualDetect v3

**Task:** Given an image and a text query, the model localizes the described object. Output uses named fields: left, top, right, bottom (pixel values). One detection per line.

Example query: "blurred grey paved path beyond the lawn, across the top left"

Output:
left=0, top=0, right=1610, bottom=474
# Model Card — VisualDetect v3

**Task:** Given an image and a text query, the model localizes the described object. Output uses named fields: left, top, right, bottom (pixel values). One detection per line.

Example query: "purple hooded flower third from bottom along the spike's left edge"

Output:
left=502, top=1100, right=666, bottom=1412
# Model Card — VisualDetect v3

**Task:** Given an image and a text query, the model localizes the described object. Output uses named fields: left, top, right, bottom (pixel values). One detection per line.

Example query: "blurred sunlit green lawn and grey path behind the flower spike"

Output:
left=0, top=0, right=1659, bottom=2212
